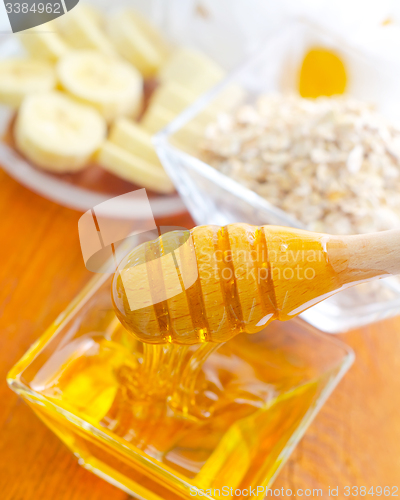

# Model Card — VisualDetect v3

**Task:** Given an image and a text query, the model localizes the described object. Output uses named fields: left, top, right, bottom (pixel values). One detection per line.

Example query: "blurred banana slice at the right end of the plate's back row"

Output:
left=108, top=10, right=169, bottom=78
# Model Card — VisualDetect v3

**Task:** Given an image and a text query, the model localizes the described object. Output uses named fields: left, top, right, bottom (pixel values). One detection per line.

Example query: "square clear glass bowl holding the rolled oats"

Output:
left=154, top=21, right=400, bottom=333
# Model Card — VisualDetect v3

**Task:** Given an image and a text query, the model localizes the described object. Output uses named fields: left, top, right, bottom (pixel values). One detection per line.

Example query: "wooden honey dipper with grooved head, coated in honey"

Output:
left=112, top=224, right=400, bottom=345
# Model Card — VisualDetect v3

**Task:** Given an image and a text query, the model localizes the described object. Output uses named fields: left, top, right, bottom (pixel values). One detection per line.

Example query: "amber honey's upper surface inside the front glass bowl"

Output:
left=27, top=321, right=319, bottom=498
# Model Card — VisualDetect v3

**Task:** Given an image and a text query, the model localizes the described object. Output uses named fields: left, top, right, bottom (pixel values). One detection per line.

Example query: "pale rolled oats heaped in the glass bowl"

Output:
left=204, top=94, right=400, bottom=234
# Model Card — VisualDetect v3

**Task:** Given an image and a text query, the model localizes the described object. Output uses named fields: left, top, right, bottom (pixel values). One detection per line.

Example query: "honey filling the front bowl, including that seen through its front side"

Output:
left=25, top=314, right=332, bottom=494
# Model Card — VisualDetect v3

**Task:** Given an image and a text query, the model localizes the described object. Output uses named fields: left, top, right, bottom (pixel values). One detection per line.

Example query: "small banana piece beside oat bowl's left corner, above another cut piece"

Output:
left=108, top=118, right=163, bottom=168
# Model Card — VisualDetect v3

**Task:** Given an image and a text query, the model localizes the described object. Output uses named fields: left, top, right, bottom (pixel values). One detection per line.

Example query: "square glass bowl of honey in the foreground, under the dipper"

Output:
left=8, top=275, right=353, bottom=500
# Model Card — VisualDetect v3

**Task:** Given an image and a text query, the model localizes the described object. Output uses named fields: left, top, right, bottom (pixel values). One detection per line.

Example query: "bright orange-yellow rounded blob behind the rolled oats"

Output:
left=299, top=47, right=347, bottom=98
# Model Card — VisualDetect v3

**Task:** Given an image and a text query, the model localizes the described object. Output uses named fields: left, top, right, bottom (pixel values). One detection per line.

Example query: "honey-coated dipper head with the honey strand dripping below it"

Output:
left=108, top=224, right=396, bottom=424
